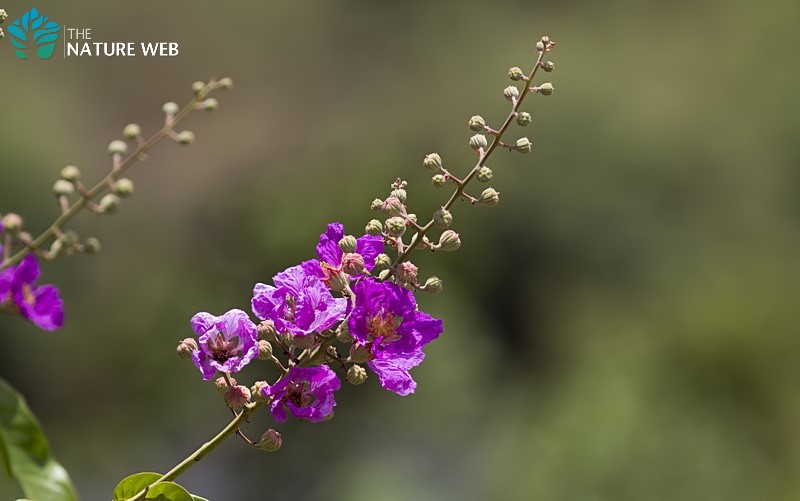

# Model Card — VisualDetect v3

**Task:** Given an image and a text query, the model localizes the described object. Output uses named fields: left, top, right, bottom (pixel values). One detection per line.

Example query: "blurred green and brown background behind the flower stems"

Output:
left=0, top=0, right=800, bottom=501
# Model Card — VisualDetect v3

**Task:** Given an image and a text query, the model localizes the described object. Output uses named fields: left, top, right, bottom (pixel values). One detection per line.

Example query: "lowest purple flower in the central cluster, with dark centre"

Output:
left=261, top=365, right=342, bottom=423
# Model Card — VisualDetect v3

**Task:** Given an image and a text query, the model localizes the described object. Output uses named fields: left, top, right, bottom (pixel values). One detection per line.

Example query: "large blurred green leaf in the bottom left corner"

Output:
left=0, top=378, right=78, bottom=501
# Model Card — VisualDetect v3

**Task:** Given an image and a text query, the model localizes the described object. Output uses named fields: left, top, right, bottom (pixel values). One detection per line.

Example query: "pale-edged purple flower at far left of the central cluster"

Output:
left=191, top=310, right=258, bottom=381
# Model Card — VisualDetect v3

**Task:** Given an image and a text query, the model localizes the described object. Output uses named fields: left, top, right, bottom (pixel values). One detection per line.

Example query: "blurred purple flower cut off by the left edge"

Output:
left=0, top=254, right=64, bottom=331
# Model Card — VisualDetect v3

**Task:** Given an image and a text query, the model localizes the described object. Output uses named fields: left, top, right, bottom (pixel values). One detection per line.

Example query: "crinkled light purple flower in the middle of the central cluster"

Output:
left=251, top=262, right=347, bottom=336
